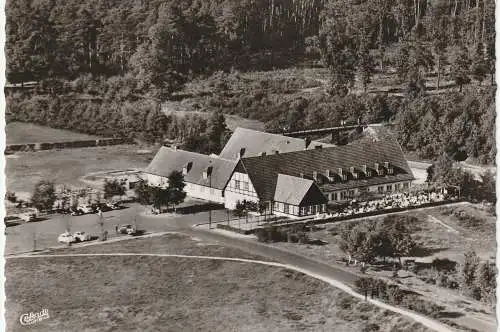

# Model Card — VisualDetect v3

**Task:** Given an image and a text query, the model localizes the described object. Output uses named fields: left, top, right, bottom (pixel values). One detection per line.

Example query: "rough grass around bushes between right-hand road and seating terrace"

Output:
left=273, top=204, right=496, bottom=331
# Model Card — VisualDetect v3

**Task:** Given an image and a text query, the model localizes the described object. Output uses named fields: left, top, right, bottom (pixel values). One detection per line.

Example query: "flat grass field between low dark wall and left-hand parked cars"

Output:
left=6, top=145, right=156, bottom=196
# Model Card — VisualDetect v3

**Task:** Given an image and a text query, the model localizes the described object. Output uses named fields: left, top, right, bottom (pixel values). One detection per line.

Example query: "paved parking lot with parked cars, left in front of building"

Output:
left=5, top=204, right=227, bottom=255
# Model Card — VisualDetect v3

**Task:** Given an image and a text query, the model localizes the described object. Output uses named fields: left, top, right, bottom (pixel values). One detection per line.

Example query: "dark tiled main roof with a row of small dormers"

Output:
left=241, top=140, right=414, bottom=200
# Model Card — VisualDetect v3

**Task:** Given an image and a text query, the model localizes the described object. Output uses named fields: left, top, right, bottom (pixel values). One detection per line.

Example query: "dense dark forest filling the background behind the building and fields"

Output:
left=6, top=0, right=495, bottom=162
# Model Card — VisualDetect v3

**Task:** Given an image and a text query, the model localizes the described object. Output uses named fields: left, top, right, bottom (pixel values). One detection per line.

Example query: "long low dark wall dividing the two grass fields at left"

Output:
left=5, top=138, right=134, bottom=153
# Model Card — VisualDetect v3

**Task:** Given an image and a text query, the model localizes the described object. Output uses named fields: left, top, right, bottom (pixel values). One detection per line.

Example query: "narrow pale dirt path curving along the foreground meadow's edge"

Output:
left=6, top=253, right=452, bottom=332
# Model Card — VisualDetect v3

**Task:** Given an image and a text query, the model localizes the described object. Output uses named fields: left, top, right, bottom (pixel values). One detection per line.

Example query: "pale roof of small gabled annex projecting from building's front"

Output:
left=274, top=174, right=327, bottom=206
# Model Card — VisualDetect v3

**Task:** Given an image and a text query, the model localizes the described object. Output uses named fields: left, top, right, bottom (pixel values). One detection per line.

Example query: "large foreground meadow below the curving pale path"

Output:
left=6, top=233, right=428, bottom=332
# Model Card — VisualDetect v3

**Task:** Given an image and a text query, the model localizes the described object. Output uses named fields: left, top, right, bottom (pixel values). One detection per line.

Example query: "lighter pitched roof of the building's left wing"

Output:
left=144, top=147, right=237, bottom=189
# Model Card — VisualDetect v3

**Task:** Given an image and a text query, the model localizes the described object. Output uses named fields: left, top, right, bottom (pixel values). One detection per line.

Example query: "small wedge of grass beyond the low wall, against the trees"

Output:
left=5, top=121, right=99, bottom=144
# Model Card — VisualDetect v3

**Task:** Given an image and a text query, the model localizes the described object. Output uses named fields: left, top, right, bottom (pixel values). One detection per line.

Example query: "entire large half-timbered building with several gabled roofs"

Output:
left=145, top=129, right=414, bottom=217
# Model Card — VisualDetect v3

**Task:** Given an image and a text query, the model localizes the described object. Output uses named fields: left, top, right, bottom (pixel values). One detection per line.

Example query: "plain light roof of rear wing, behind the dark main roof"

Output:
left=220, top=127, right=333, bottom=160
